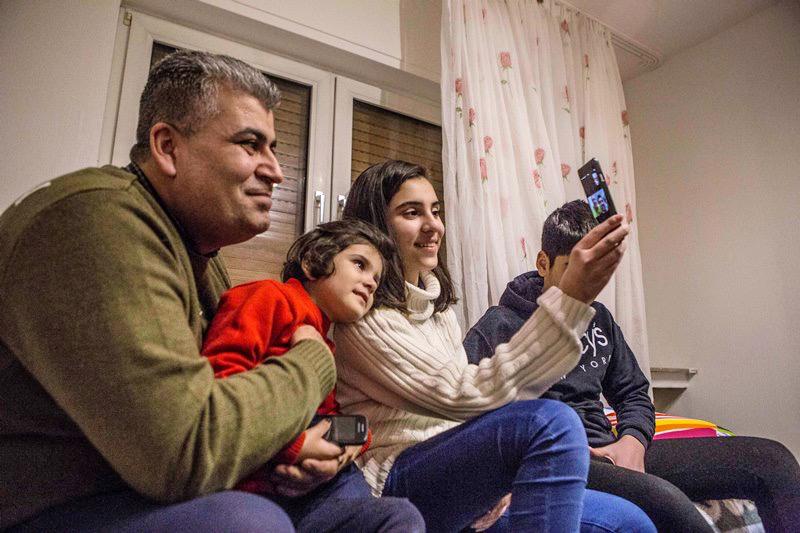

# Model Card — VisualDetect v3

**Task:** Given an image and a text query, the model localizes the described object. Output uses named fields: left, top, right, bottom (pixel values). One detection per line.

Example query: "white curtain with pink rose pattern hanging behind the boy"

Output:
left=442, top=0, right=649, bottom=374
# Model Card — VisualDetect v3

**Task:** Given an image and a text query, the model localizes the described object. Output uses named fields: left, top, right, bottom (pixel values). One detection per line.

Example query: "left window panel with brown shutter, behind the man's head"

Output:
left=111, top=13, right=334, bottom=284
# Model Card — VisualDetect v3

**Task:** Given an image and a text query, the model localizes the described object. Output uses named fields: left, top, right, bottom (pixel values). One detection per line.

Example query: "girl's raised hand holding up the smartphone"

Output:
left=559, top=215, right=630, bottom=304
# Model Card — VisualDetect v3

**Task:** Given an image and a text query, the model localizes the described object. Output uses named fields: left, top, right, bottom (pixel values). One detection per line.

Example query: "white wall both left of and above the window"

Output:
left=0, top=0, right=441, bottom=212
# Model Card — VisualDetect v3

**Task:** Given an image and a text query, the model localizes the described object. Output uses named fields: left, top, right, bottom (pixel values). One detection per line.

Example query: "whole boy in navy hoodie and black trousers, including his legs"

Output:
left=464, top=200, right=800, bottom=531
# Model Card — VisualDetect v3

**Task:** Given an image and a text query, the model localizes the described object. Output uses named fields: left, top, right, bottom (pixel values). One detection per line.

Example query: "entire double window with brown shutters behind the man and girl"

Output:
left=107, top=13, right=443, bottom=284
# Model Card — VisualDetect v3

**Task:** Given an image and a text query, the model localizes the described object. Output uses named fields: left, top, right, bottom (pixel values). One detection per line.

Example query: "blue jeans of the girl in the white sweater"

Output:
left=383, top=400, right=655, bottom=533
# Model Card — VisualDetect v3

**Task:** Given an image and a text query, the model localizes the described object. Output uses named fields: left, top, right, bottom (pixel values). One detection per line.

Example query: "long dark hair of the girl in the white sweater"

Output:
left=344, top=160, right=457, bottom=313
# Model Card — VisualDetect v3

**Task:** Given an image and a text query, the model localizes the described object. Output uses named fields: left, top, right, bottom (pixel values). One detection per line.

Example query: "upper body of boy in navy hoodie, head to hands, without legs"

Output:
left=464, top=200, right=655, bottom=464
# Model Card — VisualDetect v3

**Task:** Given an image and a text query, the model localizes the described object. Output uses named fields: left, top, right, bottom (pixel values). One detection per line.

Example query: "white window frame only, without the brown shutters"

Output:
left=101, top=8, right=442, bottom=225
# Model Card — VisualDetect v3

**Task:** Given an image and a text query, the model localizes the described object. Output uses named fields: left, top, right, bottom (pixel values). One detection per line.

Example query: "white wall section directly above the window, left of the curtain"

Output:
left=125, top=0, right=442, bottom=98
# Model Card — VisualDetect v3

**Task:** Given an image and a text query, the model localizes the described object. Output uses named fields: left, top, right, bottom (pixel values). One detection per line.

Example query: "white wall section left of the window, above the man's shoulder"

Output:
left=0, top=0, right=119, bottom=212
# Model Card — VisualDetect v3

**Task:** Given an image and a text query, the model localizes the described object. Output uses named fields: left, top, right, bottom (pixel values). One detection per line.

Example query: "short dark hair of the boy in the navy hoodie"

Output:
left=542, top=200, right=597, bottom=265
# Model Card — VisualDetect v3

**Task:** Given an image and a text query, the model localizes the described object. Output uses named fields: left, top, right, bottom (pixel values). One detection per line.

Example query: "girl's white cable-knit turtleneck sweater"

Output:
left=334, top=272, right=594, bottom=496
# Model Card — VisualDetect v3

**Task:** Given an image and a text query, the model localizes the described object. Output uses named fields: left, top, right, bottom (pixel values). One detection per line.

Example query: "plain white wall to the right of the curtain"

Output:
left=625, top=0, right=800, bottom=457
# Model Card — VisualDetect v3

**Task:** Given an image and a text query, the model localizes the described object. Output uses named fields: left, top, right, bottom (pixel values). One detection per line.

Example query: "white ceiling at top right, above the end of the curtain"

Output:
left=564, top=0, right=776, bottom=81
